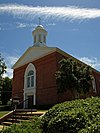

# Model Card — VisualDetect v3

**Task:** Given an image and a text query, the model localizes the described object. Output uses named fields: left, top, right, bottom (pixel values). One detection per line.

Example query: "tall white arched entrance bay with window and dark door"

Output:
left=24, top=63, right=36, bottom=109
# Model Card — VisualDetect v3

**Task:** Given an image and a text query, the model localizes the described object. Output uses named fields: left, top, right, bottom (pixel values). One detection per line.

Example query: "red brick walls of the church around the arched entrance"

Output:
left=12, top=52, right=100, bottom=105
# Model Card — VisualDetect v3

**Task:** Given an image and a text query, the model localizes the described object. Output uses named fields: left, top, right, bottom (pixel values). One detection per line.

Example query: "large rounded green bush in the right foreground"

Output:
left=41, top=97, right=100, bottom=133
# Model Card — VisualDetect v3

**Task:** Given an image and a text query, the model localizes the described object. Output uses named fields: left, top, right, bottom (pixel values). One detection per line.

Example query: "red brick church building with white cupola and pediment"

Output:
left=12, top=25, right=100, bottom=108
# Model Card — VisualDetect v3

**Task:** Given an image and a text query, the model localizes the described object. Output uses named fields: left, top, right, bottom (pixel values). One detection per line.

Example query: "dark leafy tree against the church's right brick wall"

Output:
left=56, top=58, right=92, bottom=94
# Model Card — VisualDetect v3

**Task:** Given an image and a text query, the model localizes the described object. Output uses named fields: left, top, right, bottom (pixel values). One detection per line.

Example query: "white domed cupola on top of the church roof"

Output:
left=32, top=25, right=47, bottom=46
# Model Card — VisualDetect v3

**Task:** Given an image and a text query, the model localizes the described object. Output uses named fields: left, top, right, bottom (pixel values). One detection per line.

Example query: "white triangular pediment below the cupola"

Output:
left=12, top=46, right=56, bottom=69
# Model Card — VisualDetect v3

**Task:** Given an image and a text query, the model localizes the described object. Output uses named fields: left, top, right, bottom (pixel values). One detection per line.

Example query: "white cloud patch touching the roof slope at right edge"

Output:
left=79, top=57, right=100, bottom=71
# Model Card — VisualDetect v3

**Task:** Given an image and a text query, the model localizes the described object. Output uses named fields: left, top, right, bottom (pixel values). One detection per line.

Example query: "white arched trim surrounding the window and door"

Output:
left=24, top=63, right=36, bottom=108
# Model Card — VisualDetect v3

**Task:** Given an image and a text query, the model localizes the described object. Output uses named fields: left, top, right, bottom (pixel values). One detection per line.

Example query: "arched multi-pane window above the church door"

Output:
left=27, top=70, right=34, bottom=88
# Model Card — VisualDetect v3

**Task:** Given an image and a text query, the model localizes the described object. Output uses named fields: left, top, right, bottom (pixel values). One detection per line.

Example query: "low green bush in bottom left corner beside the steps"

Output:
left=0, top=118, right=42, bottom=133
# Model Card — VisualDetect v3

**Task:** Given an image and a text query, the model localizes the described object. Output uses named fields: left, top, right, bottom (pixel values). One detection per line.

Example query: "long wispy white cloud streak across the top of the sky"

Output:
left=0, top=4, right=100, bottom=20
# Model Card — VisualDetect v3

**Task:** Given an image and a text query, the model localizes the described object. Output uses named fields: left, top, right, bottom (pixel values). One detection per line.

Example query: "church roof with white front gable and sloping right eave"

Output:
left=12, top=46, right=100, bottom=74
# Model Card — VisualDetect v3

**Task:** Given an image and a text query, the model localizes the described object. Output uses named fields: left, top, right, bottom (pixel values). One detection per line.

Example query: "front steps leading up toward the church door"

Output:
left=0, top=109, right=44, bottom=127
